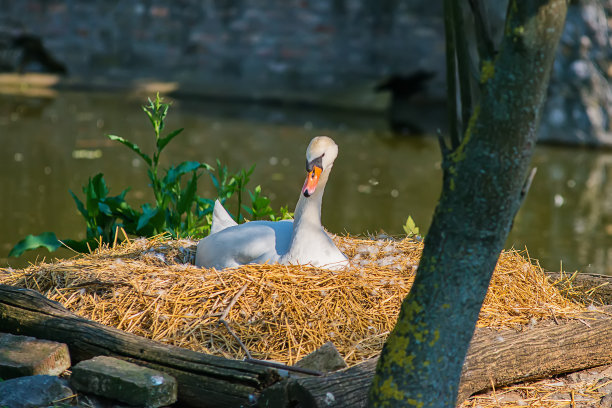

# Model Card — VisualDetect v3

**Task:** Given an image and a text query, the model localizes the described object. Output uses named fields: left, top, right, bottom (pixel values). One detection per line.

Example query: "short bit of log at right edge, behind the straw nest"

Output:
left=546, top=272, right=612, bottom=305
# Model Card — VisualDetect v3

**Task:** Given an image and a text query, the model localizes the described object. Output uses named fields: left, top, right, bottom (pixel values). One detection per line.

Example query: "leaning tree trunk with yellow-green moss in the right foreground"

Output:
left=370, top=0, right=567, bottom=407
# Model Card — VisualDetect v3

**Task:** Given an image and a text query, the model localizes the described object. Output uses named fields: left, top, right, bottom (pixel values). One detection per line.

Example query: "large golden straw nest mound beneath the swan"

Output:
left=0, top=237, right=583, bottom=365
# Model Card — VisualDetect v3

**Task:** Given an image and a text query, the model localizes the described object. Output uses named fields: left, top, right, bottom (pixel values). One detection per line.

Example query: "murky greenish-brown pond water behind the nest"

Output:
left=0, top=92, right=612, bottom=274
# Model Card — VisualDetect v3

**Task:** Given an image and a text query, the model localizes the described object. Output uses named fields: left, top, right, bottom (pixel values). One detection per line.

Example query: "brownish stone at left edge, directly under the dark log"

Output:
left=0, top=333, right=70, bottom=379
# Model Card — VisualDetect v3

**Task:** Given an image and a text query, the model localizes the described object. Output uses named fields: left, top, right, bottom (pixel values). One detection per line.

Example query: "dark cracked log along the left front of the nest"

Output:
left=0, top=285, right=279, bottom=407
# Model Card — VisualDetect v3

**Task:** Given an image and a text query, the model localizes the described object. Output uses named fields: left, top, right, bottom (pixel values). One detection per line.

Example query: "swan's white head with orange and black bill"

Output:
left=302, top=136, right=338, bottom=197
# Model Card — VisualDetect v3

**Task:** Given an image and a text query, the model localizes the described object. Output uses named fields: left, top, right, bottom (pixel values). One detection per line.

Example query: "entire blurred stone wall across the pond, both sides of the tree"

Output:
left=0, top=0, right=612, bottom=145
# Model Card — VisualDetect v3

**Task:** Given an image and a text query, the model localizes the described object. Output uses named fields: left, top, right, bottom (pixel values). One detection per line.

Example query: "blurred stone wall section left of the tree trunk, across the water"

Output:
left=0, top=0, right=444, bottom=96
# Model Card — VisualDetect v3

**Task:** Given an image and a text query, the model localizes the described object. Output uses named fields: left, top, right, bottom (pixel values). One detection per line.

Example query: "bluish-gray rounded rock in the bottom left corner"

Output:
left=0, top=375, right=74, bottom=408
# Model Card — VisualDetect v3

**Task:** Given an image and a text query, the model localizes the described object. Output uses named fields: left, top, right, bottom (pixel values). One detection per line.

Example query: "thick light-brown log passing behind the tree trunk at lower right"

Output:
left=258, top=307, right=612, bottom=408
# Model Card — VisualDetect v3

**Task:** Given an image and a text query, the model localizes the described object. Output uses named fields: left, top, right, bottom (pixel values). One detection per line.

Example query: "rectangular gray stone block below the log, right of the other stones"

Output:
left=70, top=356, right=177, bottom=407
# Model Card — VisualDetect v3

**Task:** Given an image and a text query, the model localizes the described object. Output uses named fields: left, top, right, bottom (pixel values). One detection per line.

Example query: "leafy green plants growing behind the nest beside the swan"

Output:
left=9, top=94, right=292, bottom=256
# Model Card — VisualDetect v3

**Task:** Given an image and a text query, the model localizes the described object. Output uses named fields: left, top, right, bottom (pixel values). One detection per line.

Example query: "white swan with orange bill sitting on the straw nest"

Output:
left=195, top=136, right=349, bottom=270
